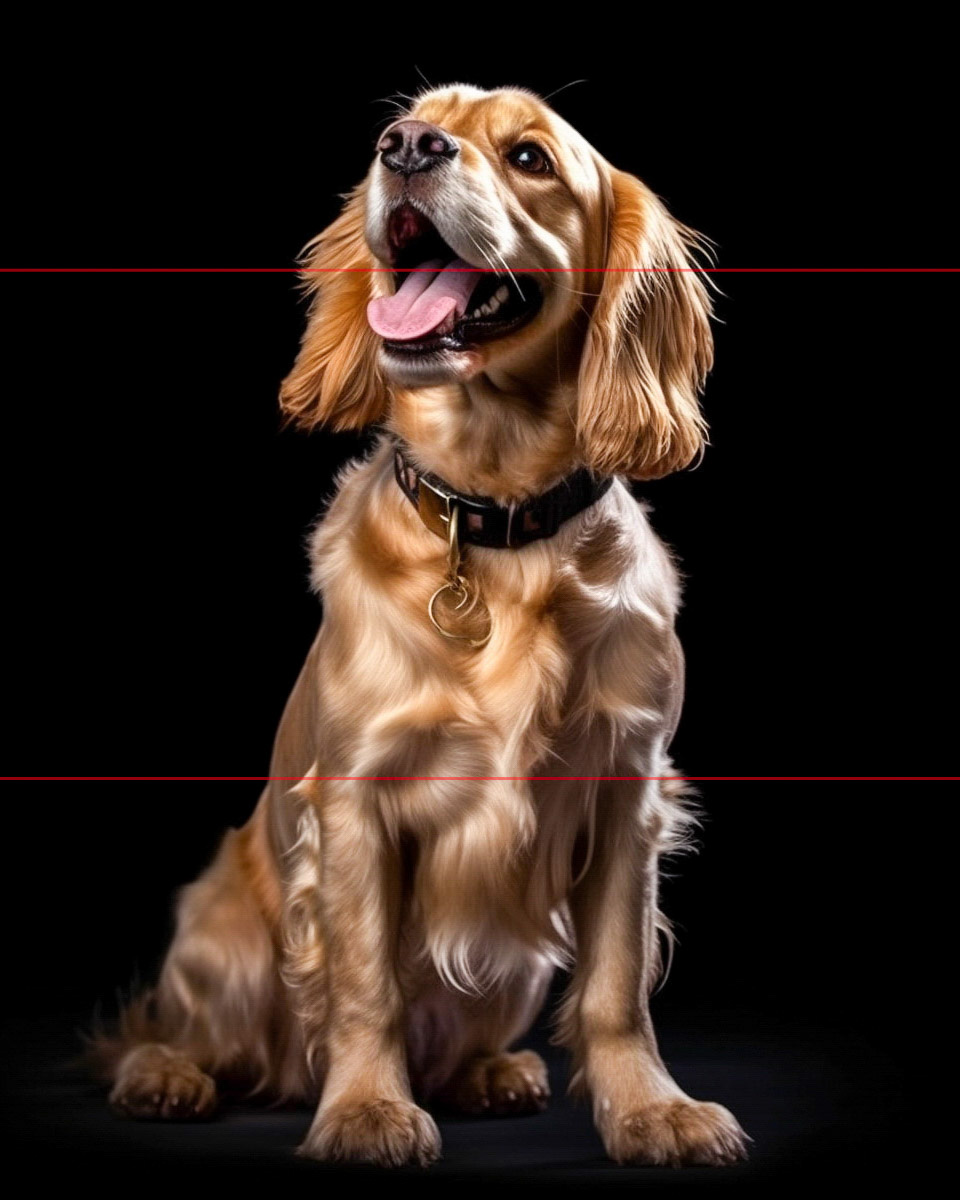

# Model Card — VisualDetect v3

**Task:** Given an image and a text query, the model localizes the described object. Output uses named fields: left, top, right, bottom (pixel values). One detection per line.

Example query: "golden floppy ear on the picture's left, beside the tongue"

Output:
left=280, top=184, right=389, bottom=430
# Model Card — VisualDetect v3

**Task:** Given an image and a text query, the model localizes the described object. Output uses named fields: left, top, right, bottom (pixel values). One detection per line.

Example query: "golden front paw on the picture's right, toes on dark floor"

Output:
left=600, top=1098, right=748, bottom=1166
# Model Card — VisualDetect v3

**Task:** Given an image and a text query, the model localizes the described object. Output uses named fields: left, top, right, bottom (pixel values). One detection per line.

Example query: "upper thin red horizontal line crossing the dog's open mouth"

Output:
left=0, top=266, right=960, bottom=275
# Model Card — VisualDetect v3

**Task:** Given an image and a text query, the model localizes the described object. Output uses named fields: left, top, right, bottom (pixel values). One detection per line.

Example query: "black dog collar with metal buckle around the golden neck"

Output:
left=394, top=445, right=613, bottom=550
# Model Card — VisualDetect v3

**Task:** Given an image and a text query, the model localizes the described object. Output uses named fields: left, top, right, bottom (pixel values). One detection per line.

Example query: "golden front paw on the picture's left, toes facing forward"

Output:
left=298, top=1100, right=440, bottom=1166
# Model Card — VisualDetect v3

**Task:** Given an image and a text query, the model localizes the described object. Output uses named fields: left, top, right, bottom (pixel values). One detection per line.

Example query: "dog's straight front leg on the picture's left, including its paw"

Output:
left=300, top=786, right=440, bottom=1166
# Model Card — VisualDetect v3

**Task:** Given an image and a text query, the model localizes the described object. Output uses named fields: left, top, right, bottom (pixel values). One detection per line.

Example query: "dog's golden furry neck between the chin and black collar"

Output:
left=389, top=374, right=581, bottom=504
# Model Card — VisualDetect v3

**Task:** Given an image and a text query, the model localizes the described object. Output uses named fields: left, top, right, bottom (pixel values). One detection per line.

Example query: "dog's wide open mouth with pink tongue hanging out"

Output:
left=367, top=204, right=542, bottom=354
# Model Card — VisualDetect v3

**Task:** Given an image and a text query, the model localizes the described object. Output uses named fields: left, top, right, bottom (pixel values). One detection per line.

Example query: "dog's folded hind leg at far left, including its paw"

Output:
left=100, top=810, right=303, bottom=1120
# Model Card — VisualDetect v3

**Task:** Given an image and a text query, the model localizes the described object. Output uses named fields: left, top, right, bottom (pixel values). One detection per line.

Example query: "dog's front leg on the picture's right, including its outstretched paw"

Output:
left=565, top=782, right=745, bottom=1166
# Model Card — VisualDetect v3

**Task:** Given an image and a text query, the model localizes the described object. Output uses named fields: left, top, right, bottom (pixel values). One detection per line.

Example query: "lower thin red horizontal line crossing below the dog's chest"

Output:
left=0, top=775, right=960, bottom=784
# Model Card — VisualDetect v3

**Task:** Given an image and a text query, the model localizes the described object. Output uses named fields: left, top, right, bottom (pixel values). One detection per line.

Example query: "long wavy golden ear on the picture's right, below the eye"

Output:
left=577, top=170, right=713, bottom=479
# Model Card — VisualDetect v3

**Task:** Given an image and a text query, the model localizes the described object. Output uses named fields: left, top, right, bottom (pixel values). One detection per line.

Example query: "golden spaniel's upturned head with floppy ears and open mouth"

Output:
left=281, top=85, right=713, bottom=478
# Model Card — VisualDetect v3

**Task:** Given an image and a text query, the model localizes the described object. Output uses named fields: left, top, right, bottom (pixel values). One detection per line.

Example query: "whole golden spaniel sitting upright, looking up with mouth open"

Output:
left=98, top=85, right=746, bottom=1166
